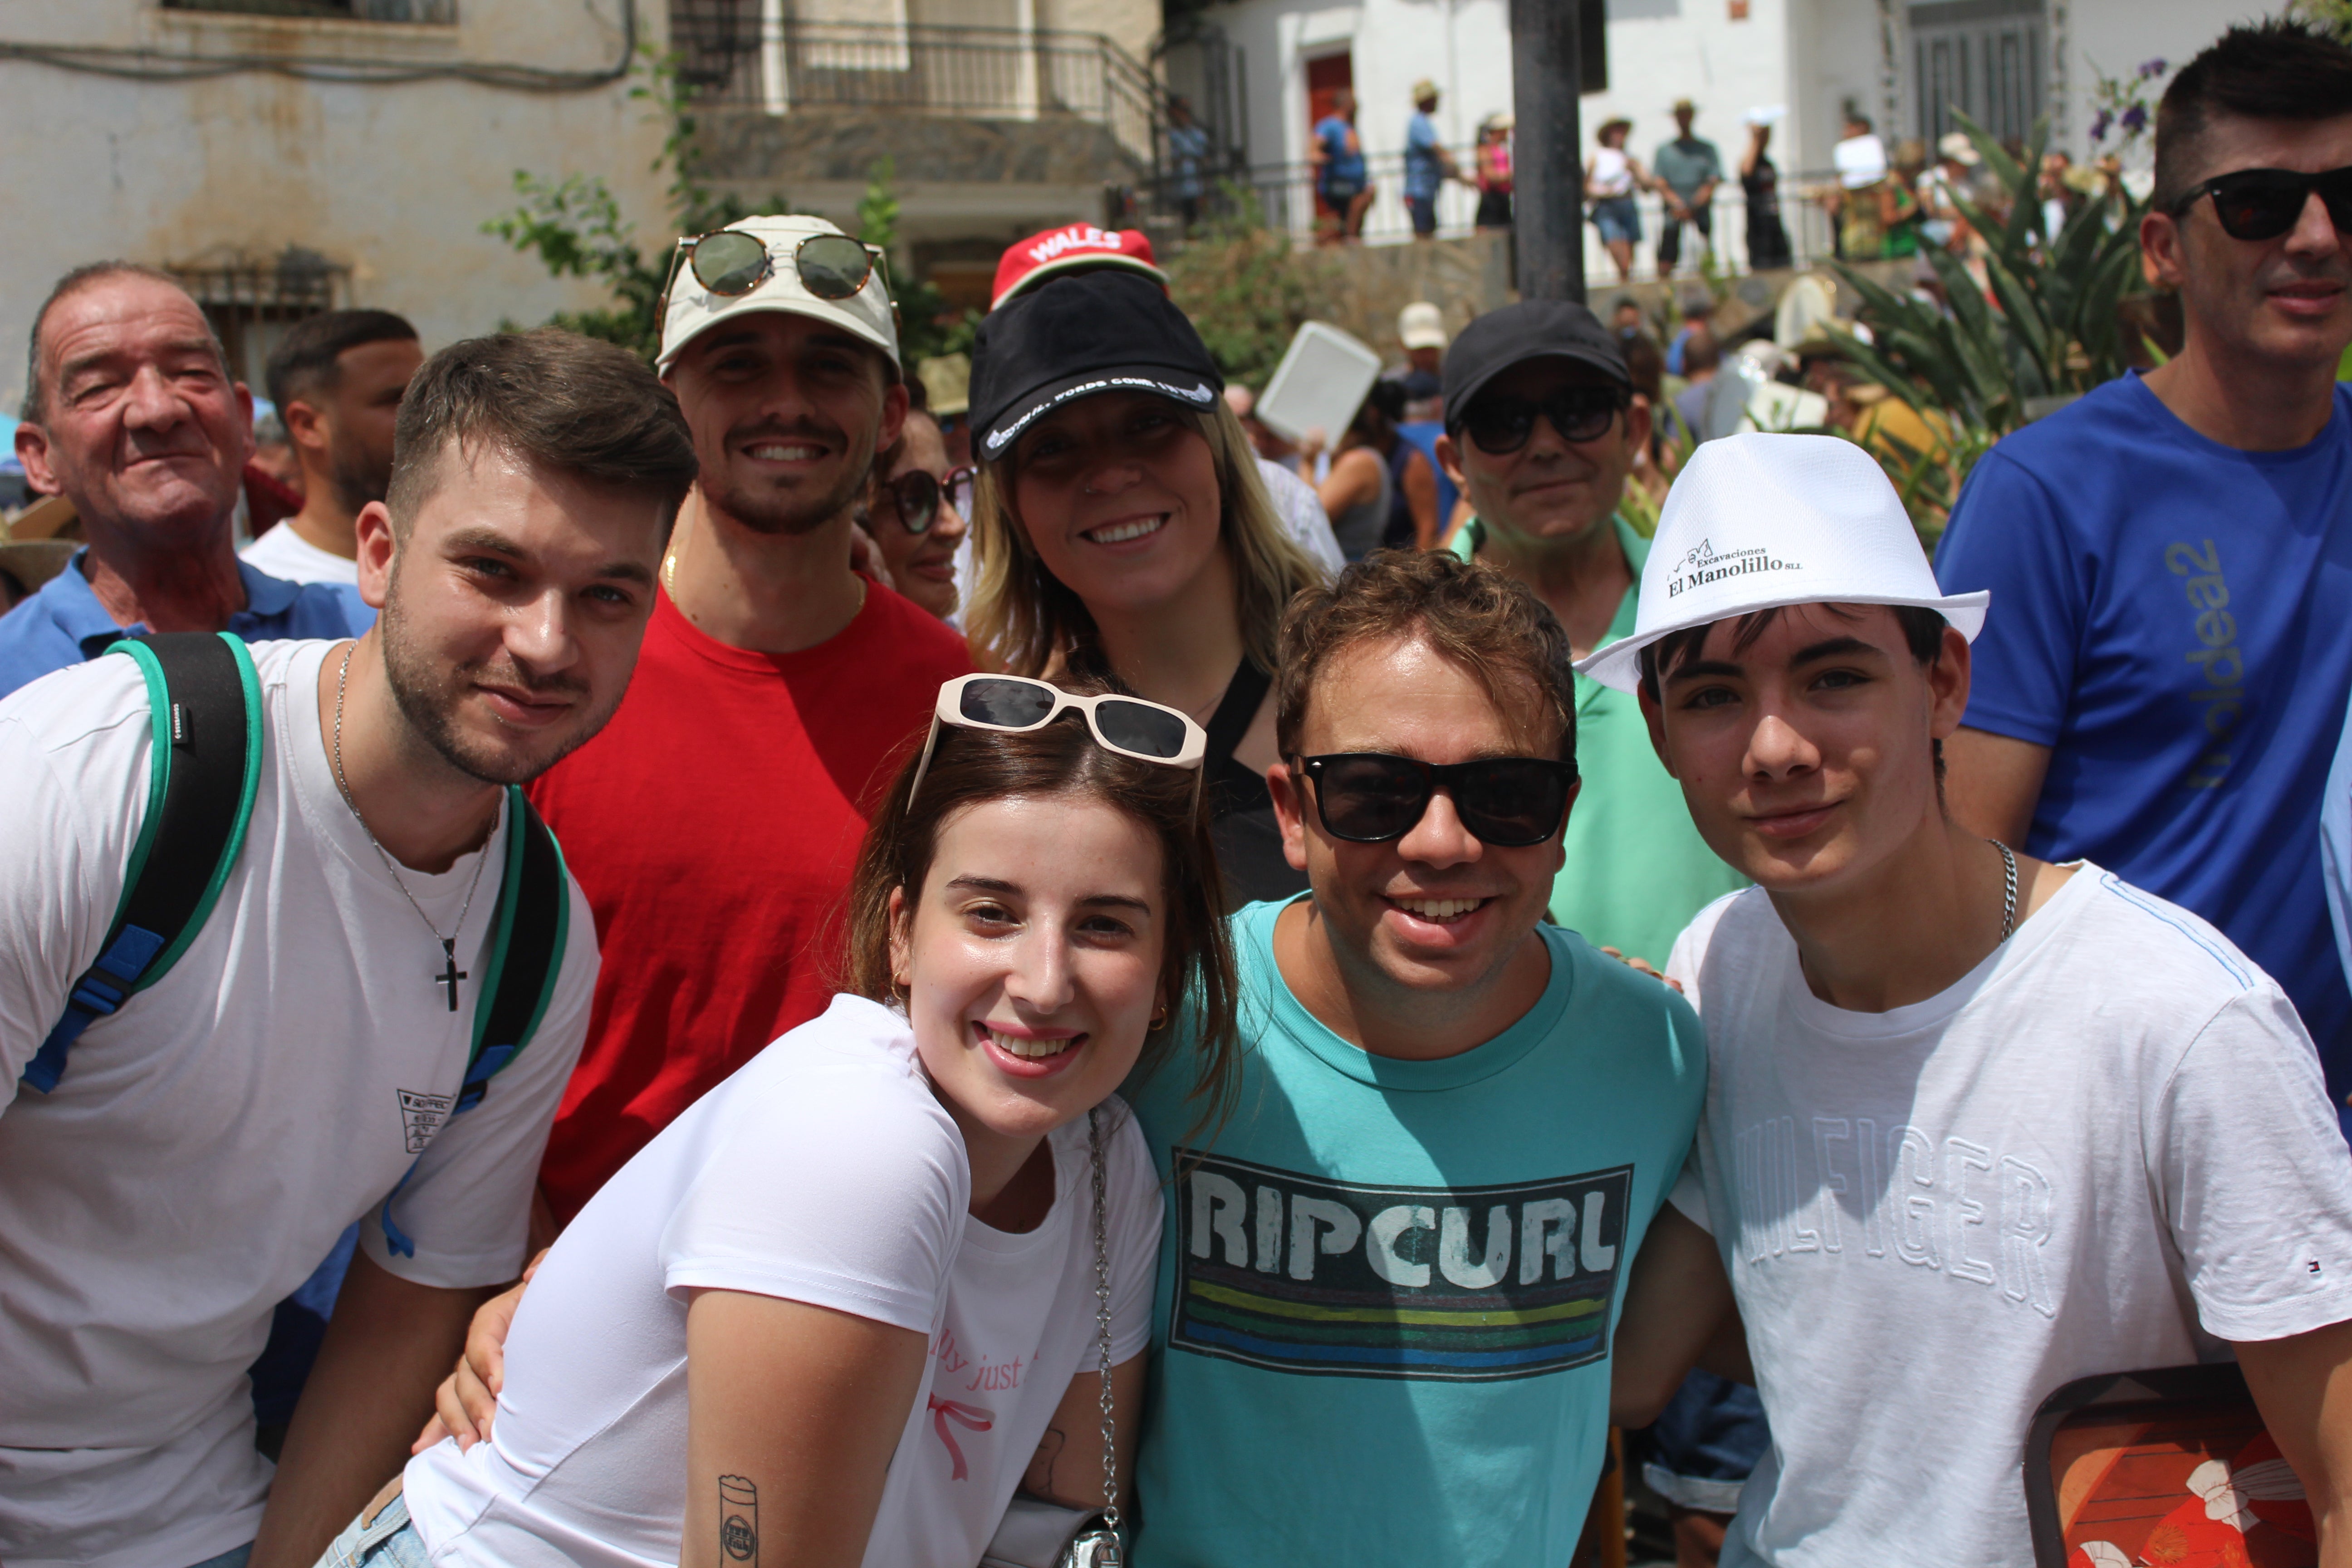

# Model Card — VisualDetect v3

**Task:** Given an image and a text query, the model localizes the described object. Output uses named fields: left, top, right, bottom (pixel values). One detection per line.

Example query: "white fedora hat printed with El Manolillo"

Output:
left=1576, top=432, right=1992, bottom=691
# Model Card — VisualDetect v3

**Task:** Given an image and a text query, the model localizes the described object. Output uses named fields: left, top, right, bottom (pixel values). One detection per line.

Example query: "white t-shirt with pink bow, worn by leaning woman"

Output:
left=407, top=997, right=1160, bottom=1568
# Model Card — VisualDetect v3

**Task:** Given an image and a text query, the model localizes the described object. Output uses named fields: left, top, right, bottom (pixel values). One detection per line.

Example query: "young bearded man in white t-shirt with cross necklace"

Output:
left=0, top=334, right=694, bottom=1568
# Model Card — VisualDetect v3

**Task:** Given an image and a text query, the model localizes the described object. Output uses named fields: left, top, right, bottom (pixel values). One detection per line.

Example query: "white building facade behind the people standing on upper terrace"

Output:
left=1204, top=0, right=2258, bottom=277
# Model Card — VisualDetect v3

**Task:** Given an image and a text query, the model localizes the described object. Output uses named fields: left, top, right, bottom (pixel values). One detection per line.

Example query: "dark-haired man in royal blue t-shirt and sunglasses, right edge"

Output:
left=1936, top=24, right=2352, bottom=1133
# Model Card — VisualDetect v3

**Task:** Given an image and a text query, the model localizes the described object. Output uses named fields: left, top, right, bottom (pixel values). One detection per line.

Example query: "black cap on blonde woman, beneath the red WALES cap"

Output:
left=971, top=270, right=1225, bottom=461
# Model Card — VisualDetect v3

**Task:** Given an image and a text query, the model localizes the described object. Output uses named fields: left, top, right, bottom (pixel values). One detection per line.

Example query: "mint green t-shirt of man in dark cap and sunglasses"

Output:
left=1449, top=515, right=1748, bottom=969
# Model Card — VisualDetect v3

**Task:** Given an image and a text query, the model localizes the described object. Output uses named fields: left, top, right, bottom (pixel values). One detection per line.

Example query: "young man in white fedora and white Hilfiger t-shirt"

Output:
left=1581, top=435, right=2352, bottom=1568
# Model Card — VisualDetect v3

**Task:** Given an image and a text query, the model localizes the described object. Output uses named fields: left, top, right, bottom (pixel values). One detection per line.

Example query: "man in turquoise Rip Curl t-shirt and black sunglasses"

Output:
left=1129, top=553, right=1705, bottom=1568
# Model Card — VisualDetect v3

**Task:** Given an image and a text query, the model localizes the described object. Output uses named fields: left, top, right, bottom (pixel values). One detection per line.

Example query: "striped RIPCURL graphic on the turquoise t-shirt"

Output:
left=1169, top=1150, right=1632, bottom=1382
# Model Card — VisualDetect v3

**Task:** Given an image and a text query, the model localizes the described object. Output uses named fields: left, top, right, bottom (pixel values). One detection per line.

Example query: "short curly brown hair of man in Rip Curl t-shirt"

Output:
left=1275, top=550, right=1576, bottom=762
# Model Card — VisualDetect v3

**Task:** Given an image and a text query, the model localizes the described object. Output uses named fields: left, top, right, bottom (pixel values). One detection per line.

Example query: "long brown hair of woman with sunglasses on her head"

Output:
left=840, top=679, right=1240, bottom=1136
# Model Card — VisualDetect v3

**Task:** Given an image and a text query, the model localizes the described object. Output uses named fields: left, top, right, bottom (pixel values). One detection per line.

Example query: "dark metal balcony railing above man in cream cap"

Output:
left=670, top=0, right=1162, bottom=174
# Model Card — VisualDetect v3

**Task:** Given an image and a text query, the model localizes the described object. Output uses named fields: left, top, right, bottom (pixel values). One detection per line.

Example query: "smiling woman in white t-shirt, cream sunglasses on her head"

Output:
left=322, top=675, right=1235, bottom=1568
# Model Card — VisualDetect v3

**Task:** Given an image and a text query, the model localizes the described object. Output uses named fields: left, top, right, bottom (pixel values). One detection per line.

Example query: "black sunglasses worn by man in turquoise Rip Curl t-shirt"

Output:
left=1298, top=752, right=1576, bottom=848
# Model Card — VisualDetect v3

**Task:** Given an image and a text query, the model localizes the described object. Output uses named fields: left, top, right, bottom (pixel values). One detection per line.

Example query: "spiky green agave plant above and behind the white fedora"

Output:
left=1835, top=115, right=2145, bottom=512
